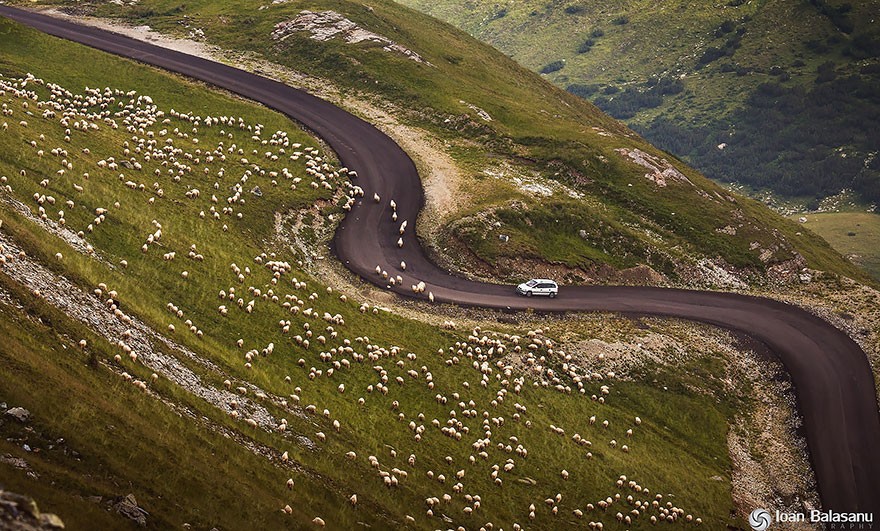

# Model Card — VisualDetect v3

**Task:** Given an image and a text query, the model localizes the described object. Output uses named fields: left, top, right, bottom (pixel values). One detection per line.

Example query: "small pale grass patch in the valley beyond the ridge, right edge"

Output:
left=796, top=212, right=880, bottom=279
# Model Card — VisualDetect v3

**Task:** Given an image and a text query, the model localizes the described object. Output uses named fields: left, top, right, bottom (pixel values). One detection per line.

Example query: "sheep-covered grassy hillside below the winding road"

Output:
left=0, top=16, right=754, bottom=529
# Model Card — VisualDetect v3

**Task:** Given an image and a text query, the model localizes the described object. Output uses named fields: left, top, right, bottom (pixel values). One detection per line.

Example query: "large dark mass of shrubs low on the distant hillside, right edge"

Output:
left=640, top=71, right=880, bottom=204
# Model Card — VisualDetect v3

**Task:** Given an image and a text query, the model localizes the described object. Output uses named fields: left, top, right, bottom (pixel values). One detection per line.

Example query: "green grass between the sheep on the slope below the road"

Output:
left=0, top=17, right=756, bottom=529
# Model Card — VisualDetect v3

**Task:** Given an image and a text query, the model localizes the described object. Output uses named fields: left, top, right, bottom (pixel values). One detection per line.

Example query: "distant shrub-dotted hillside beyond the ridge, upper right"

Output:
left=394, top=0, right=880, bottom=201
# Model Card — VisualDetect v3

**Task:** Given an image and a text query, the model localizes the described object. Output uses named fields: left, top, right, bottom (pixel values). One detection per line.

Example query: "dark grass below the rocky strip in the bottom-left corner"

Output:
left=0, top=275, right=370, bottom=529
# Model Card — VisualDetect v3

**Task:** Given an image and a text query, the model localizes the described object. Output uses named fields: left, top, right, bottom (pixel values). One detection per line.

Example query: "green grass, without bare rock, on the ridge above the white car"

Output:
left=15, top=0, right=861, bottom=281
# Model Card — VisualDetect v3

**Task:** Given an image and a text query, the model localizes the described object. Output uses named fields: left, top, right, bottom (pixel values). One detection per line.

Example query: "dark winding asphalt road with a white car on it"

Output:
left=0, top=6, right=880, bottom=518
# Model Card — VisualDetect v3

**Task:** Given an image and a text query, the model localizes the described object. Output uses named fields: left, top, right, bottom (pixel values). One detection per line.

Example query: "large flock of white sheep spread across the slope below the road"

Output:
left=0, top=71, right=702, bottom=530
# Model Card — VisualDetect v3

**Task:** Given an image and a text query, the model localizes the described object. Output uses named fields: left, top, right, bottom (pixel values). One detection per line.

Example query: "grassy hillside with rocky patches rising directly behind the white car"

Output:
left=15, top=0, right=865, bottom=285
